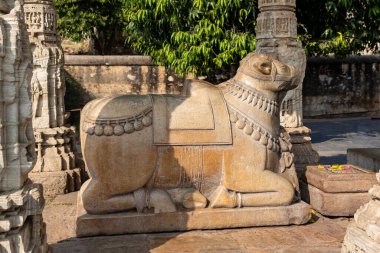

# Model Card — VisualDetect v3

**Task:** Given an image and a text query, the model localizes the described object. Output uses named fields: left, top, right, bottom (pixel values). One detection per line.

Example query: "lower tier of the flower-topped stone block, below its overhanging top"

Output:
left=300, top=181, right=371, bottom=217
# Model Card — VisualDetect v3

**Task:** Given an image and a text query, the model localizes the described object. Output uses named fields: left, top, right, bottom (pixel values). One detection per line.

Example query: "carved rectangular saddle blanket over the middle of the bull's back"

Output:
left=152, top=80, right=232, bottom=145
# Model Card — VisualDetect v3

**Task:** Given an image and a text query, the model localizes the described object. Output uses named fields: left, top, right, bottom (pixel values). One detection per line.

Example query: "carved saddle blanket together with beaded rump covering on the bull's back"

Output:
left=82, top=80, right=232, bottom=146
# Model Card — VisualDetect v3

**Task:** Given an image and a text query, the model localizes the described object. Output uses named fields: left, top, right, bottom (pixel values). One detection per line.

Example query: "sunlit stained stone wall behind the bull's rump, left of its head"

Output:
left=65, top=55, right=183, bottom=109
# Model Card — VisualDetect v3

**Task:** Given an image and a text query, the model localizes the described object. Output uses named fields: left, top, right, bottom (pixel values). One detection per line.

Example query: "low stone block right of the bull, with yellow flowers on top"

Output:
left=301, top=166, right=376, bottom=216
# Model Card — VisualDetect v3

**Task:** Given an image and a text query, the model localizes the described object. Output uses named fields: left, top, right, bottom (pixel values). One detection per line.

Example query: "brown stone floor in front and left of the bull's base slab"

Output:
left=44, top=193, right=349, bottom=253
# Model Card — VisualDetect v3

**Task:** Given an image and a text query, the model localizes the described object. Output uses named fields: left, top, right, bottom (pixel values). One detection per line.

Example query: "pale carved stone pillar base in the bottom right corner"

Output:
left=341, top=174, right=380, bottom=253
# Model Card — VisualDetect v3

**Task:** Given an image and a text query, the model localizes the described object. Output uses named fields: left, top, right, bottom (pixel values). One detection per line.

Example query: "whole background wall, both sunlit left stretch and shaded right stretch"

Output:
left=65, top=55, right=380, bottom=118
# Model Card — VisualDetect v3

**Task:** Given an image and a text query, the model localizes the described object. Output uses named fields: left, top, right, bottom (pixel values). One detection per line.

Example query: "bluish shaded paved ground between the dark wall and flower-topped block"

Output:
left=304, top=118, right=380, bottom=164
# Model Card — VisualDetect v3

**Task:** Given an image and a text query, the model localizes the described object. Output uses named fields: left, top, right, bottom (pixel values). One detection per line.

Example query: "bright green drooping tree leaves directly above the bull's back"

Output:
left=123, top=0, right=257, bottom=75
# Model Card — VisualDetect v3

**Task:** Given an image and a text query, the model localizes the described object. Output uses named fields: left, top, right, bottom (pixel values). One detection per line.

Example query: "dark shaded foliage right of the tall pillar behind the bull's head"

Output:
left=297, top=0, right=380, bottom=56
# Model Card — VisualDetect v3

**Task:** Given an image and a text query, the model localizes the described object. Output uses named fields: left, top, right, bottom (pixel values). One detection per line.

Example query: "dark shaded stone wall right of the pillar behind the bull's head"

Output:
left=303, top=56, right=380, bottom=117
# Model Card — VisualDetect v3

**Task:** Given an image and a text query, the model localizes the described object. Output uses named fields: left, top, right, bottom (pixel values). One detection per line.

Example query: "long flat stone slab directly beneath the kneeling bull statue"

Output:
left=76, top=200, right=310, bottom=237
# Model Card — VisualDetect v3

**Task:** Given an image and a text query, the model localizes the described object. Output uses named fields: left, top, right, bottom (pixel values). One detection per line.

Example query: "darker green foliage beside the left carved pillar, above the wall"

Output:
left=54, top=0, right=122, bottom=54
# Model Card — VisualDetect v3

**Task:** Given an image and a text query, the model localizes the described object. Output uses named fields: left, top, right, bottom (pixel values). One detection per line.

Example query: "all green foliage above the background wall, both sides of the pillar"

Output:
left=55, top=0, right=380, bottom=75
